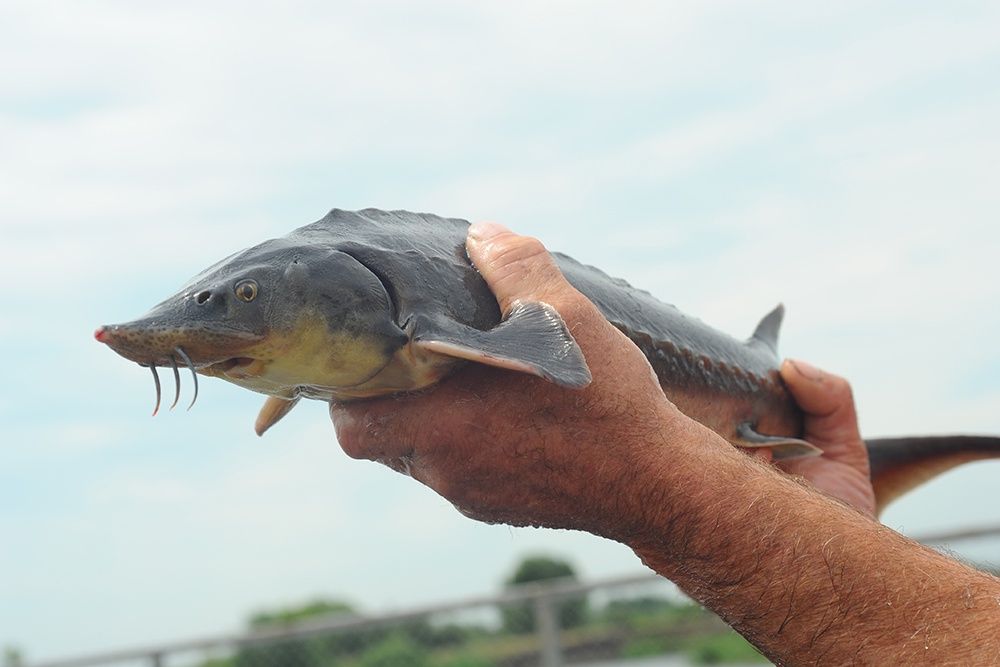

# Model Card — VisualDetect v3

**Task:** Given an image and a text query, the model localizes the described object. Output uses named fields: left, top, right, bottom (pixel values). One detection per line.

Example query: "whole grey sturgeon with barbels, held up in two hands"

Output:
left=95, top=209, right=1000, bottom=509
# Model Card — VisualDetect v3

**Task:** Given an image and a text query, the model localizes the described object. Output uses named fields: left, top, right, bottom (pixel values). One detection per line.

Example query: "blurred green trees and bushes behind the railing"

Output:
left=201, top=556, right=766, bottom=667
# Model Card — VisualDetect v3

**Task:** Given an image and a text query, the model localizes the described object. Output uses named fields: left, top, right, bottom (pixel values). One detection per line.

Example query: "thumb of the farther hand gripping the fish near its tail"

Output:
left=781, top=359, right=860, bottom=446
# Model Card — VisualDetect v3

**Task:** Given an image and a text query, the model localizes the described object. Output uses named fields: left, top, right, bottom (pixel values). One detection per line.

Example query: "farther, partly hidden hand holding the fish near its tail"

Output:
left=778, top=360, right=875, bottom=517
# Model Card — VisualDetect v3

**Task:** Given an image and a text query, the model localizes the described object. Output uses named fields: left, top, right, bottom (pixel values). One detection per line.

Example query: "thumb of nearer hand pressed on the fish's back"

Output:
left=466, top=222, right=578, bottom=313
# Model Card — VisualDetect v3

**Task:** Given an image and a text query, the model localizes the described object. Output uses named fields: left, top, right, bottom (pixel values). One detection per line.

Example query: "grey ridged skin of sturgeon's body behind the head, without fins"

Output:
left=330, top=209, right=802, bottom=444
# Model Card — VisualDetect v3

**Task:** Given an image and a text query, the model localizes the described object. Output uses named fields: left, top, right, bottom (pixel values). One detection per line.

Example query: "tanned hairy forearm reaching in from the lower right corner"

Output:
left=627, top=424, right=1000, bottom=665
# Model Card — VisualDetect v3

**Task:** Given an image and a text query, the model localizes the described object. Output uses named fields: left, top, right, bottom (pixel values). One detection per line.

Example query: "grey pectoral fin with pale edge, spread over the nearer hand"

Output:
left=411, top=302, right=591, bottom=389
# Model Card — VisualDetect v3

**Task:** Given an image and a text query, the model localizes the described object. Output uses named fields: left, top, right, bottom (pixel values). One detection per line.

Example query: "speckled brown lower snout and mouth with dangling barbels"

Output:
left=94, top=323, right=263, bottom=416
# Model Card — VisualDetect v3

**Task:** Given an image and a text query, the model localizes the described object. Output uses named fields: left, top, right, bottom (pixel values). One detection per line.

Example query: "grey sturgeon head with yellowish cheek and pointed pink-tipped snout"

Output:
left=94, top=237, right=406, bottom=398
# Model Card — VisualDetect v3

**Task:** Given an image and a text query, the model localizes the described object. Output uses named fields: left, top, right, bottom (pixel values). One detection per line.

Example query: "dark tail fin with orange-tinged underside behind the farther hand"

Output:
left=867, top=435, right=1000, bottom=513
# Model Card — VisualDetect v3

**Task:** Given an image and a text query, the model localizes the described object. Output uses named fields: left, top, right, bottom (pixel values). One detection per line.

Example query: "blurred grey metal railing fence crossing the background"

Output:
left=19, top=526, right=1000, bottom=667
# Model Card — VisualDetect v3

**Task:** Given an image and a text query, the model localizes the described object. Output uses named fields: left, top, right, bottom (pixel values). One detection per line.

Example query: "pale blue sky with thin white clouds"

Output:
left=0, top=0, right=1000, bottom=659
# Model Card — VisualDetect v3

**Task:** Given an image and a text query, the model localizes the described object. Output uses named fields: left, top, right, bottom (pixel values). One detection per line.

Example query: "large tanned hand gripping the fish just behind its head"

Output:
left=330, top=225, right=704, bottom=540
